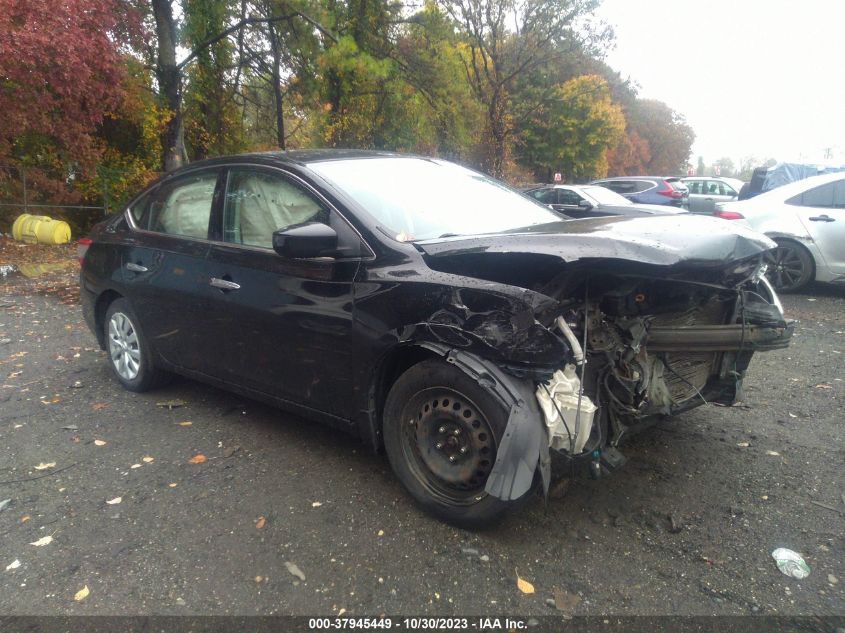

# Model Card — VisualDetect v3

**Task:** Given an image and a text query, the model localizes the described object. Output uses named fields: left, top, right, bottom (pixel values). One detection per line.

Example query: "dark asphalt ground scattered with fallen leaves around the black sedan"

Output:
left=0, top=242, right=845, bottom=617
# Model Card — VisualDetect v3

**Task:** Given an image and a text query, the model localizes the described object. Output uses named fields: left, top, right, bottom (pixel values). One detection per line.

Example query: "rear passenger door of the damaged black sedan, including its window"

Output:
left=123, top=169, right=222, bottom=372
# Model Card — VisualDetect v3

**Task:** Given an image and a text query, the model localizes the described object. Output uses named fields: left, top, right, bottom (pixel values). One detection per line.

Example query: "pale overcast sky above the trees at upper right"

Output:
left=599, top=0, right=845, bottom=164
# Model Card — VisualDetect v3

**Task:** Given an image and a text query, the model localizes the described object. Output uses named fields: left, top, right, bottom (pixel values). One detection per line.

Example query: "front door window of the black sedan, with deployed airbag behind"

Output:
left=223, top=168, right=329, bottom=248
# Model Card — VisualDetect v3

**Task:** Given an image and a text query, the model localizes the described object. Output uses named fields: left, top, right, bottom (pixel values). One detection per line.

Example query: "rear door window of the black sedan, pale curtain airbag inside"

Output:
left=146, top=170, right=217, bottom=239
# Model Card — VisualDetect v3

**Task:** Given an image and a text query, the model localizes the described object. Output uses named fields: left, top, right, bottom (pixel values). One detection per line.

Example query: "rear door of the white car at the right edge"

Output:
left=786, top=178, right=845, bottom=275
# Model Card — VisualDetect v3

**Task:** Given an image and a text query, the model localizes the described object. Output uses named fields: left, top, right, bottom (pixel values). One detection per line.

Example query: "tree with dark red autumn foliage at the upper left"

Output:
left=0, top=0, right=132, bottom=197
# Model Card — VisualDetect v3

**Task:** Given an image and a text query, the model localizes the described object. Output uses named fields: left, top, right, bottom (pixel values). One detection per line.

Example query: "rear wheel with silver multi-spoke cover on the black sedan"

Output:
left=103, top=299, right=166, bottom=392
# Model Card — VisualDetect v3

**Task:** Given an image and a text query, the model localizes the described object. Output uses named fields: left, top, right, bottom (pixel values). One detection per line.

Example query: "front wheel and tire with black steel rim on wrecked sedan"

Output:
left=383, top=360, right=534, bottom=529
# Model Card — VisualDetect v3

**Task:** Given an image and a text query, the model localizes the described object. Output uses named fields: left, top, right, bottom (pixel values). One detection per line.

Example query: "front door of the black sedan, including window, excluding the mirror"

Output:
left=204, top=166, right=363, bottom=417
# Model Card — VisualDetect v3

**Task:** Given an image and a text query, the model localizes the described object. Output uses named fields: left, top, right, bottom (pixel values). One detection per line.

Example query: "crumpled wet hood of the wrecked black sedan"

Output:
left=416, top=214, right=776, bottom=267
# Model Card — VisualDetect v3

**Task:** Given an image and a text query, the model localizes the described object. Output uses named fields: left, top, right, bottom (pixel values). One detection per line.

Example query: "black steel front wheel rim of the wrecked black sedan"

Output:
left=400, top=387, right=496, bottom=505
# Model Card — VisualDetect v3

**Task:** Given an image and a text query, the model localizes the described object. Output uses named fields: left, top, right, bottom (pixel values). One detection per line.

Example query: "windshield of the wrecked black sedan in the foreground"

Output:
left=308, top=157, right=560, bottom=242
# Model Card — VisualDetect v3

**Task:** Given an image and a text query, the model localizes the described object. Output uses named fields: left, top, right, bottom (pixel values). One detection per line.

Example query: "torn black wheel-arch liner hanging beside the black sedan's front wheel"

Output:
left=419, top=342, right=551, bottom=501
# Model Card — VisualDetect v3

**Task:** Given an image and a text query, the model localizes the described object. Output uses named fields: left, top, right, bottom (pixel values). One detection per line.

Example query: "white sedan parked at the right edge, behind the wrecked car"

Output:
left=714, top=172, right=845, bottom=292
